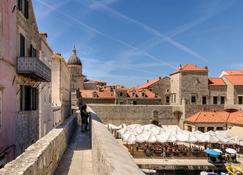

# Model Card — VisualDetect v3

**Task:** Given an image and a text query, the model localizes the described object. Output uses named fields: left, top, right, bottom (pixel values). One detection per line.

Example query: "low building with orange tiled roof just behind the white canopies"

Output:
left=184, top=111, right=243, bottom=132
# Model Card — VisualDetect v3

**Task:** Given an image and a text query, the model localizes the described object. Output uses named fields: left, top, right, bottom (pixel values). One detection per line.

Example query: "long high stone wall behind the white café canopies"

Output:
left=89, top=104, right=183, bottom=125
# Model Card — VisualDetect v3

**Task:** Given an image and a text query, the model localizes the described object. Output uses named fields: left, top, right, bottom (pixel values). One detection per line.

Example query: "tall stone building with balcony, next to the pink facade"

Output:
left=15, top=0, right=51, bottom=155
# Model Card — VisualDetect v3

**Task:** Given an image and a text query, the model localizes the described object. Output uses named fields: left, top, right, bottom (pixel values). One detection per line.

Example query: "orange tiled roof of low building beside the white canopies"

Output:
left=186, top=111, right=243, bottom=125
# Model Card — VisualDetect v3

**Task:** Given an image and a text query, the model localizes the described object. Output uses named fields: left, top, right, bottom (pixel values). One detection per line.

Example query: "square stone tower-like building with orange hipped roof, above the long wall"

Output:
left=170, top=64, right=209, bottom=105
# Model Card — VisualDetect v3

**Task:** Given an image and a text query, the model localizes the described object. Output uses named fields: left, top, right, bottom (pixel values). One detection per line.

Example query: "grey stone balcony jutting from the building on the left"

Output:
left=17, top=57, right=51, bottom=82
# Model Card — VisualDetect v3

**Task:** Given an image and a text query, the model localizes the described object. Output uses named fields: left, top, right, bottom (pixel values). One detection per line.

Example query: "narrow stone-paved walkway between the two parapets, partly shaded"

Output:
left=55, top=127, right=93, bottom=175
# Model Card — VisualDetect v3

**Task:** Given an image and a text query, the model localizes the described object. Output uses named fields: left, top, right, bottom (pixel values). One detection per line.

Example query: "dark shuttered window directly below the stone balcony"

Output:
left=20, top=85, right=38, bottom=111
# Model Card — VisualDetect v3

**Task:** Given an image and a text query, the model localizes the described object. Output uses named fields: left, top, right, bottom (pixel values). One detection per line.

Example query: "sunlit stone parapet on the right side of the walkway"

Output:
left=92, top=110, right=144, bottom=175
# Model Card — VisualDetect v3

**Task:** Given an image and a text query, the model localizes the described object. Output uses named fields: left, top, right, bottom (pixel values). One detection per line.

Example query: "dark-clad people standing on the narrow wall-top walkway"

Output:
left=79, top=104, right=90, bottom=132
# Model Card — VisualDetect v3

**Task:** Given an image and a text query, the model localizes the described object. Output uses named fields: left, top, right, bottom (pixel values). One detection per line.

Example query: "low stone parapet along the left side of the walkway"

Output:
left=0, top=116, right=76, bottom=175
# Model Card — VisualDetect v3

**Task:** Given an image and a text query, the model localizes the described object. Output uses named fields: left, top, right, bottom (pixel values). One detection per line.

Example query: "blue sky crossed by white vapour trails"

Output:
left=33, top=0, right=243, bottom=86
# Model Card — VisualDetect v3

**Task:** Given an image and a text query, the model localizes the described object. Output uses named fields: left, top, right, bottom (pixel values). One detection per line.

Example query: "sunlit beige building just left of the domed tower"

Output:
left=51, top=53, right=71, bottom=126
